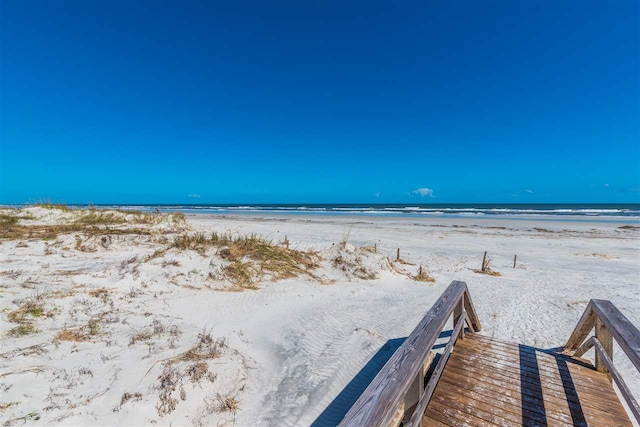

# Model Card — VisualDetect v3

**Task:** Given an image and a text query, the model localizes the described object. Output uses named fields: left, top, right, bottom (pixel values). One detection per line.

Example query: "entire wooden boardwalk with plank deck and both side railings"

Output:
left=340, top=281, right=640, bottom=427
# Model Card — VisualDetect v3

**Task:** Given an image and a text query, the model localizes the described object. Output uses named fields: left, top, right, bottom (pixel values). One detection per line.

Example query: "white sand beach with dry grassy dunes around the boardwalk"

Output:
left=0, top=207, right=640, bottom=426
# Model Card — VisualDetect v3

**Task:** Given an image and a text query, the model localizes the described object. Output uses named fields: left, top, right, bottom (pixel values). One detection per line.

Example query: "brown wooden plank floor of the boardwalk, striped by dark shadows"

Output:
left=422, top=334, right=632, bottom=427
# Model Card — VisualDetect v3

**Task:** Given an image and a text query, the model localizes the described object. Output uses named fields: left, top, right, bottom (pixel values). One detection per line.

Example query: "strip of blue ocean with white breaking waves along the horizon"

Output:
left=91, top=204, right=640, bottom=220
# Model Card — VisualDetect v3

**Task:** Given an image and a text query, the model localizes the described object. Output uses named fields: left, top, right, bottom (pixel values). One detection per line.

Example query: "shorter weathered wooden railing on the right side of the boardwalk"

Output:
left=564, top=299, right=640, bottom=422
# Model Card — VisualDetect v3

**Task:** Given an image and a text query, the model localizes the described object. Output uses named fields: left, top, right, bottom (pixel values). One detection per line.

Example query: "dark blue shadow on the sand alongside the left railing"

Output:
left=311, top=330, right=453, bottom=427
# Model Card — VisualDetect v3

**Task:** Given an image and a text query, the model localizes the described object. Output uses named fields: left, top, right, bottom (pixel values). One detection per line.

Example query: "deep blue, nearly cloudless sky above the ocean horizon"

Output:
left=0, top=0, right=640, bottom=203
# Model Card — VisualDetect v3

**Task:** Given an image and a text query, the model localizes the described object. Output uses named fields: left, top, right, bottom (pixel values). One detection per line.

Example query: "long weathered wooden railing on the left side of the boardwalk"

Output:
left=340, top=282, right=481, bottom=427
